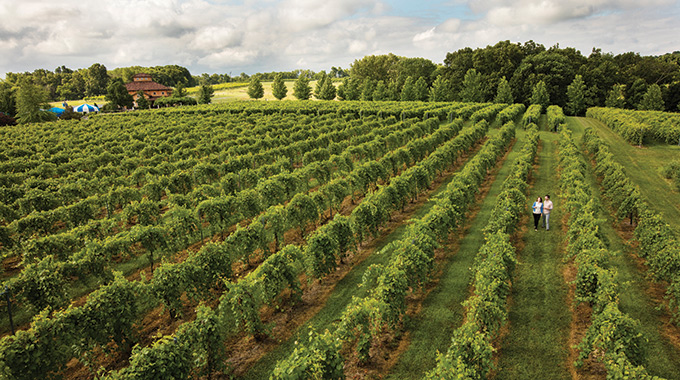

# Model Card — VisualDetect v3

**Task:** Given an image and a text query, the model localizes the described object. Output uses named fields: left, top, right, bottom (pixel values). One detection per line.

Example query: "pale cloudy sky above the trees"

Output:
left=0, top=0, right=680, bottom=78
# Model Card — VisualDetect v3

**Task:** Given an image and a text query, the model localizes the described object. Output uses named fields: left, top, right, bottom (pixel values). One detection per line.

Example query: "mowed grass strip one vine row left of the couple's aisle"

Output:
left=387, top=128, right=524, bottom=380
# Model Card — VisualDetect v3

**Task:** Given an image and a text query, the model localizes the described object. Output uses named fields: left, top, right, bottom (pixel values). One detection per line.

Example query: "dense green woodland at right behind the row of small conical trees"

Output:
left=351, top=41, right=680, bottom=112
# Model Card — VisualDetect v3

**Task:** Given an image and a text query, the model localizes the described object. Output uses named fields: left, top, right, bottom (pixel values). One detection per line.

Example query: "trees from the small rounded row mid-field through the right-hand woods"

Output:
left=242, top=41, right=680, bottom=115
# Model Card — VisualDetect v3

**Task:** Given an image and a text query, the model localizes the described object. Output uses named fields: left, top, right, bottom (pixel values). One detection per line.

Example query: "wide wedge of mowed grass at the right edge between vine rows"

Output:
left=577, top=118, right=680, bottom=235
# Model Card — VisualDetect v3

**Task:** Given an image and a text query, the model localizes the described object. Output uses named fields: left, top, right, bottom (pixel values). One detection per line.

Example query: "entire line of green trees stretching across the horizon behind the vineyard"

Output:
left=0, top=41, right=680, bottom=121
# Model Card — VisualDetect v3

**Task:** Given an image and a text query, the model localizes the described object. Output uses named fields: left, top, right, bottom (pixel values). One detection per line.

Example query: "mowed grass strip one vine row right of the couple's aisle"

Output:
left=569, top=118, right=680, bottom=379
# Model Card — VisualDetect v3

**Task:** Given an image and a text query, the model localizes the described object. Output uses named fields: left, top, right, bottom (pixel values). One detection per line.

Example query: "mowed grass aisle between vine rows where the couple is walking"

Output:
left=496, top=131, right=571, bottom=380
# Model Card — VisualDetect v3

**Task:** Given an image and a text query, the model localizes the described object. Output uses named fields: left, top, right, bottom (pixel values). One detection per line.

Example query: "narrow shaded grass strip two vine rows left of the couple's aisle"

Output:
left=243, top=125, right=497, bottom=379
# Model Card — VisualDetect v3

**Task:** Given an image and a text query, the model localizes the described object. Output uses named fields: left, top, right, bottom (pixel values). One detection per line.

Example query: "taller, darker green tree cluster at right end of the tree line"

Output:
left=437, top=41, right=680, bottom=115
